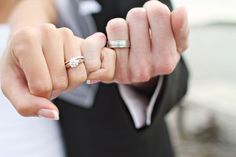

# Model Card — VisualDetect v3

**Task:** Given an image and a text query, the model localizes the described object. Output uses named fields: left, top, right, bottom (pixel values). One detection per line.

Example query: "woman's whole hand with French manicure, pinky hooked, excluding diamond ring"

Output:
left=1, top=24, right=116, bottom=120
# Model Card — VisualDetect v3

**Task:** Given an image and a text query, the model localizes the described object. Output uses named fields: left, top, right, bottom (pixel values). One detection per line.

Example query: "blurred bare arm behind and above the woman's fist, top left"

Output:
left=8, top=0, right=57, bottom=32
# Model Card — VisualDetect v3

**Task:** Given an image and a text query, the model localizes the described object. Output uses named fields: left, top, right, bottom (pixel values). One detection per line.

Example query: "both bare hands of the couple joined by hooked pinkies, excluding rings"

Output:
left=1, top=1, right=189, bottom=119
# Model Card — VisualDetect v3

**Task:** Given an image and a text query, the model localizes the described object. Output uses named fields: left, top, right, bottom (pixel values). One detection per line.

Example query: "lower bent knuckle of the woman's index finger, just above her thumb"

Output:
left=29, top=81, right=52, bottom=98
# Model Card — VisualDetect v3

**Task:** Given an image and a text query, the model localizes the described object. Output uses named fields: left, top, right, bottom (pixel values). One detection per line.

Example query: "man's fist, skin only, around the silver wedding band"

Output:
left=102, top=0, right=189, bottom=87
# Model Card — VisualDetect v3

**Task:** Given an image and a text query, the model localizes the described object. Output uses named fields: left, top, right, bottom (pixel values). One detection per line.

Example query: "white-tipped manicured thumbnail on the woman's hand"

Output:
left=38, top=109, right=59, bottom=120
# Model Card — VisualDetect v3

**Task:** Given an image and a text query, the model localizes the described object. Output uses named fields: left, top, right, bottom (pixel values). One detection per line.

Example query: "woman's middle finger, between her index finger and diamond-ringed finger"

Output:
left=41, top=25, right=68, bottom=98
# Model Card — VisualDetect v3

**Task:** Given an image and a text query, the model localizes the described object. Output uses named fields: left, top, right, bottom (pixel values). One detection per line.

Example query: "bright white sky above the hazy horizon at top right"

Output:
left=172, top=0, right=236, bottom=25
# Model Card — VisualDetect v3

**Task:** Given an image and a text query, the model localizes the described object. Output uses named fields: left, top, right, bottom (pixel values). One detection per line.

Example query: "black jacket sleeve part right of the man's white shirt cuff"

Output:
left=152, top=58, right=189, bottom=122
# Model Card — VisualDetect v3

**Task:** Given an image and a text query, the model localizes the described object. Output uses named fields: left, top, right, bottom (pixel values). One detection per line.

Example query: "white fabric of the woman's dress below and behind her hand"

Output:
left=0, top=24, right=65, bottom=157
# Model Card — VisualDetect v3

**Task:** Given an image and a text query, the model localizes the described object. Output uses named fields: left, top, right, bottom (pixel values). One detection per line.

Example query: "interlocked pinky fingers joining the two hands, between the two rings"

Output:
left=81, top=33, right=116, bottom=84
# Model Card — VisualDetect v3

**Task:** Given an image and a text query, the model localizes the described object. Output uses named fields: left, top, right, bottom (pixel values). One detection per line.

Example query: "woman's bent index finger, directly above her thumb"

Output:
left=9, top=29, right=52, bottom=98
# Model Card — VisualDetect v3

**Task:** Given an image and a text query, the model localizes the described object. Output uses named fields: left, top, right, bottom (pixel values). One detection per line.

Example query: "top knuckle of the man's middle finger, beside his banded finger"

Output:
left=126, top=8, right=146, bottom=21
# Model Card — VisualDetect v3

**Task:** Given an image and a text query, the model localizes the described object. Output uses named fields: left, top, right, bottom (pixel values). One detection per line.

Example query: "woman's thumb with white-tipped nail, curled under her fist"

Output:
left=1, top=64, right=59, bottom=120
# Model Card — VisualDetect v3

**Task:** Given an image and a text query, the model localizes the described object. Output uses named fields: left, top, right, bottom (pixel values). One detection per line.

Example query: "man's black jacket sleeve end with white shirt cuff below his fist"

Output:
left=116, top=59, right=188, bottom=129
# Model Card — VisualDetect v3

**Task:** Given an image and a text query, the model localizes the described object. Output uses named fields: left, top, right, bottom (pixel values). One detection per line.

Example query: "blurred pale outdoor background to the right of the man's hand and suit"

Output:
left=167, top=0, right=236, bottom=157
